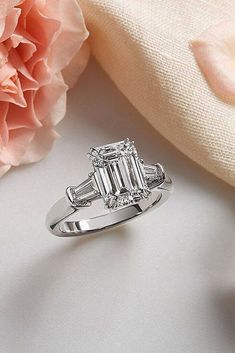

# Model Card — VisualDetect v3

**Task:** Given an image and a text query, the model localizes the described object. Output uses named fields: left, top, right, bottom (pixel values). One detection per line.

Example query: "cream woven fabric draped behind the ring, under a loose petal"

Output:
left=79, top=0, right=235, bottom=185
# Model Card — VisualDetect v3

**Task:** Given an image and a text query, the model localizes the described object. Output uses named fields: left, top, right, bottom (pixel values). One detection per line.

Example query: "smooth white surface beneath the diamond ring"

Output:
left=0, top=58, right=235, bottom=353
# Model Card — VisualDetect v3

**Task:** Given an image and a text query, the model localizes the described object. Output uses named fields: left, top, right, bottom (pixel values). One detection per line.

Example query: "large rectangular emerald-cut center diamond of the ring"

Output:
left=89, top=139, right=150, bottom=208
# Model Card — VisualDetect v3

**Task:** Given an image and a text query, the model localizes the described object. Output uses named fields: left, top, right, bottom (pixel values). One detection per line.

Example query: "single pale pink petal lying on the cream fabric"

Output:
left=191, top=21, right=235, bottom=104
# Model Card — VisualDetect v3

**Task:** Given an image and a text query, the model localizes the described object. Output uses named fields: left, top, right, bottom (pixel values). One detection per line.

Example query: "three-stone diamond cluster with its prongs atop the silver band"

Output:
left=66, top=138, right=165, bottom=209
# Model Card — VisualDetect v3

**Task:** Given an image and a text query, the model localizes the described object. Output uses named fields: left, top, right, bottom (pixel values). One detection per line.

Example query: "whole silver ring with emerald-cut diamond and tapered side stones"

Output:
left=46, top=139, right=172, bottom=237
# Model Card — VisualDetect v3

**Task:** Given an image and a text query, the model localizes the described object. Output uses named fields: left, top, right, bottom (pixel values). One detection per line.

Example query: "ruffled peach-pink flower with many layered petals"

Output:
left=0, top=0, right=88, bottom=176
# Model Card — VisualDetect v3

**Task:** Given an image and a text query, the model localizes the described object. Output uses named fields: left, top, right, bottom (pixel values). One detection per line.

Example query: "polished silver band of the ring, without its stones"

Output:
left=46, top=177, right=172, bottom=237
